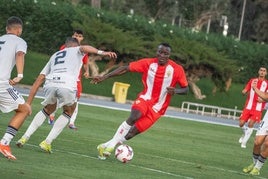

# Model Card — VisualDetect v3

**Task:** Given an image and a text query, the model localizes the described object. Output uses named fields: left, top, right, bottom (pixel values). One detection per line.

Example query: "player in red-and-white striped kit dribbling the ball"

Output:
left=91, top=43, right=188, bottom=160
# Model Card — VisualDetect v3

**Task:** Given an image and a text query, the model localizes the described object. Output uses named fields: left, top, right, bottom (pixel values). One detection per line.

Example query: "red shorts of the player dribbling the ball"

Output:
left=132, top=98, right=161, bottom=132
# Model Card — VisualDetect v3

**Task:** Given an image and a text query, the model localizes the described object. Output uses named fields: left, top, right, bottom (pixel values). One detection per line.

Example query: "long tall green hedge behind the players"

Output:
left=0, top=0, right=268, bottom=84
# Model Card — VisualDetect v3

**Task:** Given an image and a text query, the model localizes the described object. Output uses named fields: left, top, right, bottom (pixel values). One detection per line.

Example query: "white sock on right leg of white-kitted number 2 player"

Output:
left=46, top=114, right=70, bottom=144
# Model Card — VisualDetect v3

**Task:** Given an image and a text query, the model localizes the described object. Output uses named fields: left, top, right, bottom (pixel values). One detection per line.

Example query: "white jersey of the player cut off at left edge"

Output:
left=0, top=34, right=27, bottom=84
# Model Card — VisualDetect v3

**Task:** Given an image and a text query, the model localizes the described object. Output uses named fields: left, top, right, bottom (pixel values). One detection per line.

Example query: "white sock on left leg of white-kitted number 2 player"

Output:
left=22, top=110, right=47, bottom=140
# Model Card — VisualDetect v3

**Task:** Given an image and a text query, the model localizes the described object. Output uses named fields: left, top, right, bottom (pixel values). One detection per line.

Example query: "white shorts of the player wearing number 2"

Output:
left=41, top=87, right=76, bottom=107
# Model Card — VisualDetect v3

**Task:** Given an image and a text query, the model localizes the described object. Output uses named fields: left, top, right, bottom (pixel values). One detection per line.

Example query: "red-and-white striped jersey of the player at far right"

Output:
left=245, top=78, right=268, bottom=111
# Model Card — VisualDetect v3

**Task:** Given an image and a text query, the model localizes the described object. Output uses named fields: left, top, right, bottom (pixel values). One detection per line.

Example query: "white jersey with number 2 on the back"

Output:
left=40, top=47, right=84, bottom=90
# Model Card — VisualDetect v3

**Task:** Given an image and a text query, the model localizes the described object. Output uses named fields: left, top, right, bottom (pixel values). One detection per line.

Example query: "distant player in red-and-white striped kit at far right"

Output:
left=239, top=67, right=268, bottom=148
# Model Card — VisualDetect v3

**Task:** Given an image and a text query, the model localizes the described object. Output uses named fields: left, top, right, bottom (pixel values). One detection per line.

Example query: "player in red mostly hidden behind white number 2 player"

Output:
left=48, top=29, right=89, bottom=130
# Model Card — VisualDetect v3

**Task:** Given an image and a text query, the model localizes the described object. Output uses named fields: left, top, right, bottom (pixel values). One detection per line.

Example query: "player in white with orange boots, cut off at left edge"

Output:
left=0, top=16, right=31, bottom=160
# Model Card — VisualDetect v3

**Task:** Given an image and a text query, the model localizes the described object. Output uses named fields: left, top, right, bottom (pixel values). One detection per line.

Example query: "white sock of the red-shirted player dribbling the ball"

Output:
left=104, top=121, right=131, bottom=148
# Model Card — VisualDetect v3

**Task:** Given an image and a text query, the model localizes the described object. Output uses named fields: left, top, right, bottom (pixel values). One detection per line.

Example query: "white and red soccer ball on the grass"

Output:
left=115, top=144, right=134, bottom=163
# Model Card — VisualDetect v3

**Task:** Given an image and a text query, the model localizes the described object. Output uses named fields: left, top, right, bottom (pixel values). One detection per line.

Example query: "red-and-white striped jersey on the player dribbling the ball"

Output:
left=129, top=58, right=188, bottom=114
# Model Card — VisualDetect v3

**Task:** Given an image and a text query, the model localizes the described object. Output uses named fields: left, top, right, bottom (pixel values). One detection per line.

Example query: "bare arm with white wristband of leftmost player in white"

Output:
left=9, top=51, right=25, bottom=85
